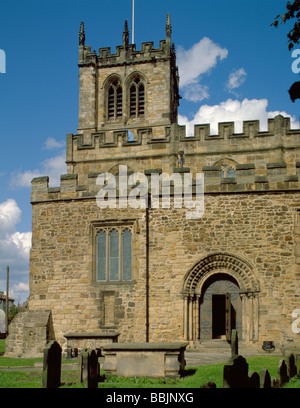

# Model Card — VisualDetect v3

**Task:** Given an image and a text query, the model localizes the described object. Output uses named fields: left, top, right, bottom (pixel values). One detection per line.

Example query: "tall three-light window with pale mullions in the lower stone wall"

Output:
left=96, top=228, right=132, bottom=282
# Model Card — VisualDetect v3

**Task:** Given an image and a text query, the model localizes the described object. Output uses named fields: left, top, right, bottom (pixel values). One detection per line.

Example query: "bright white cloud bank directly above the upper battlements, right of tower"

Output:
left=178, top=99, right=297, bottom=135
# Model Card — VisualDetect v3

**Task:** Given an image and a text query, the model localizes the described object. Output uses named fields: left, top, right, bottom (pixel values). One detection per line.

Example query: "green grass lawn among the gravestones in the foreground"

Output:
left=0, top=340, right=300, bottom=388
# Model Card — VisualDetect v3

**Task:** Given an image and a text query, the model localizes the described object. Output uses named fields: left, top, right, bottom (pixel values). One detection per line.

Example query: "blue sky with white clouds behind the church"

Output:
left=0, top=0, right=300, bottom=302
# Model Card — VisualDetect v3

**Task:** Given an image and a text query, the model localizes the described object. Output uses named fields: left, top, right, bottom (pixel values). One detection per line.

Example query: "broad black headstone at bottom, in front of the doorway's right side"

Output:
left=223, top=356, right=248, bottom=388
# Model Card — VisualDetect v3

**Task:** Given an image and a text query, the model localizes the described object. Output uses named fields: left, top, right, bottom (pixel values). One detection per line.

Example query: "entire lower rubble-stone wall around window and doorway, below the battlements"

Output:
left=29, top=191, right=300, bottom=345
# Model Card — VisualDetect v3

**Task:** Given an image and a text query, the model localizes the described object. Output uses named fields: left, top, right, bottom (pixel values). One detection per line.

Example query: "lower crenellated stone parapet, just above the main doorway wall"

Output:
left=31, top=161, right=300, bottom=203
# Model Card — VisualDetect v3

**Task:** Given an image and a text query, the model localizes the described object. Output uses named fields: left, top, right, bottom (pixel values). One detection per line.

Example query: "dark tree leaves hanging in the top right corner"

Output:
left=271, top=0, right=300, bottom=50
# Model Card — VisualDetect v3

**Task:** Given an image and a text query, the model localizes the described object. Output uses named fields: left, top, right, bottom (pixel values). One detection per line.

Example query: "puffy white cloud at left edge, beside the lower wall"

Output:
left=0, top=199, right=32, bottom=302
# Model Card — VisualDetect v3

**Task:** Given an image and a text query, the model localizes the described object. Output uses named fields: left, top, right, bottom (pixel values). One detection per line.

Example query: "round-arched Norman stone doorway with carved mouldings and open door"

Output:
left=183, top=253, right=260, bottom=341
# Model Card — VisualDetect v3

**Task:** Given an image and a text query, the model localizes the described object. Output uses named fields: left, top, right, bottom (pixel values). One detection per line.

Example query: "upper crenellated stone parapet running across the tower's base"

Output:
left=67, top=115, right=300, bottom=163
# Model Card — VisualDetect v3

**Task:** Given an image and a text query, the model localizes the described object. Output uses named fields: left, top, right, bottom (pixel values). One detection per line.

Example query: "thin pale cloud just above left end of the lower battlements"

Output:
left=10, top=151, right=67, bottom=187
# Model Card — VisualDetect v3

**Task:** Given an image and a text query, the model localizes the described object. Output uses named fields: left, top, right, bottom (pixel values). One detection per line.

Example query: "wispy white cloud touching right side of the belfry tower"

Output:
left=177, top=37, right=228, bottom=102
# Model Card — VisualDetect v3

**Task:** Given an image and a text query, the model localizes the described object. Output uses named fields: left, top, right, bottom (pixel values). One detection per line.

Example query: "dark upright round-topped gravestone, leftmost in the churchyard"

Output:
left=42, top=340, right=61, bottom=388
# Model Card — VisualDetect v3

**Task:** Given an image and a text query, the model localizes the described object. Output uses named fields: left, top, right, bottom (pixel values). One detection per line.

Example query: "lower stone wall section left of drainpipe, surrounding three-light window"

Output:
left=29, top=200, right=145, bottom=345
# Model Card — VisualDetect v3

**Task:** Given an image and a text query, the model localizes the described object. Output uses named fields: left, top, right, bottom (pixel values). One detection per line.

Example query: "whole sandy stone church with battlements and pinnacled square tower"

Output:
left=6, top=16, right=300, bottom=355
